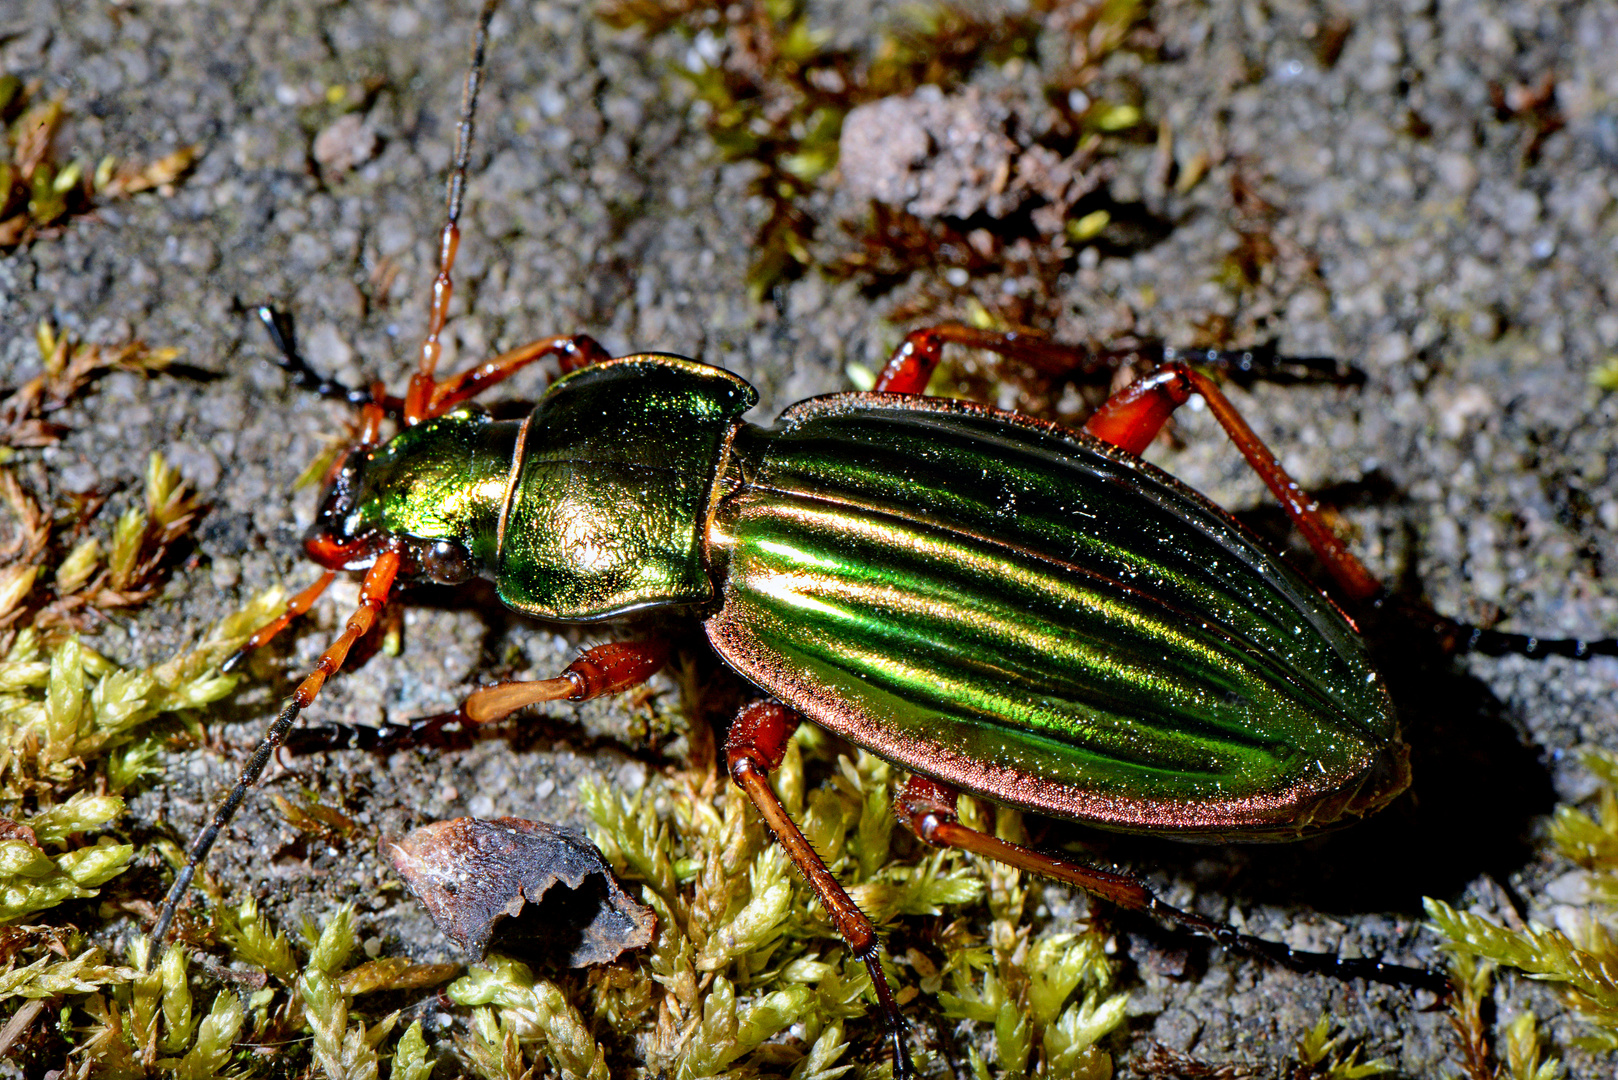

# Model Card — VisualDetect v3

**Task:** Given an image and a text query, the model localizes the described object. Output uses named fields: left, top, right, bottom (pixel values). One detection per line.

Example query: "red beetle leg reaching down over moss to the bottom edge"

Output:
left=725, top=701, right=916, bottom=1077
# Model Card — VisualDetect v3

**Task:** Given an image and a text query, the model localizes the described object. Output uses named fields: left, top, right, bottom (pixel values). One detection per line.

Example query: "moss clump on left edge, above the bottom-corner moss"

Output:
left=0, top=324, right=278, bottom=925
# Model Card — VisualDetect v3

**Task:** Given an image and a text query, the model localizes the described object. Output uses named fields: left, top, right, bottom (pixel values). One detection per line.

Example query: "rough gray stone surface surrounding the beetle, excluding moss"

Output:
left=0, top=0, right=1618, bottom=1075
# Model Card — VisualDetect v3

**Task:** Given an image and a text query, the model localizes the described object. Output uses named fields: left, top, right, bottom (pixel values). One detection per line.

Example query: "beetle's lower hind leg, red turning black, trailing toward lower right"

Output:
left=896, top=776, right=1450, bottom=994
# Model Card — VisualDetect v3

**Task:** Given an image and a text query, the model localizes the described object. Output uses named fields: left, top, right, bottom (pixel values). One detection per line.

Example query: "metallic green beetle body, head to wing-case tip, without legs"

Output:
left=331, top=356, right=1409, bottom=839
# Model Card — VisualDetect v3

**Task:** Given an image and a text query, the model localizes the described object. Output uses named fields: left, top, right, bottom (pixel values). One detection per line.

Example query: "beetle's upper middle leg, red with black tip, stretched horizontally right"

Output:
left=872, top=322, right=1364, bottom=393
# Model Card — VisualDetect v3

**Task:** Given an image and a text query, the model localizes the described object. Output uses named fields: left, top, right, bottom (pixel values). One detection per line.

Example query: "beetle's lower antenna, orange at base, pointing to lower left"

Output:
left=147, top=549, right=400, bottom=954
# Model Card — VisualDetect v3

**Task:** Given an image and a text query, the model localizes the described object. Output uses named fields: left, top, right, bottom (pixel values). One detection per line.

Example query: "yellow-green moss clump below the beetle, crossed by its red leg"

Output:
left=430, top=725, right=1123, bottom=1080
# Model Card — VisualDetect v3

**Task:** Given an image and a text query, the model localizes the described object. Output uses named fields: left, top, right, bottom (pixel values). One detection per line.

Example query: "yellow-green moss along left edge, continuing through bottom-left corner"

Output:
left=0, top=317, right=456, bottom=1080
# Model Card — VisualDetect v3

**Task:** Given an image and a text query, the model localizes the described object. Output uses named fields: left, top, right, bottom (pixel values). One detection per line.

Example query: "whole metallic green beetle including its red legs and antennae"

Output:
left=142, top=3, right=1618, bottom=1075
